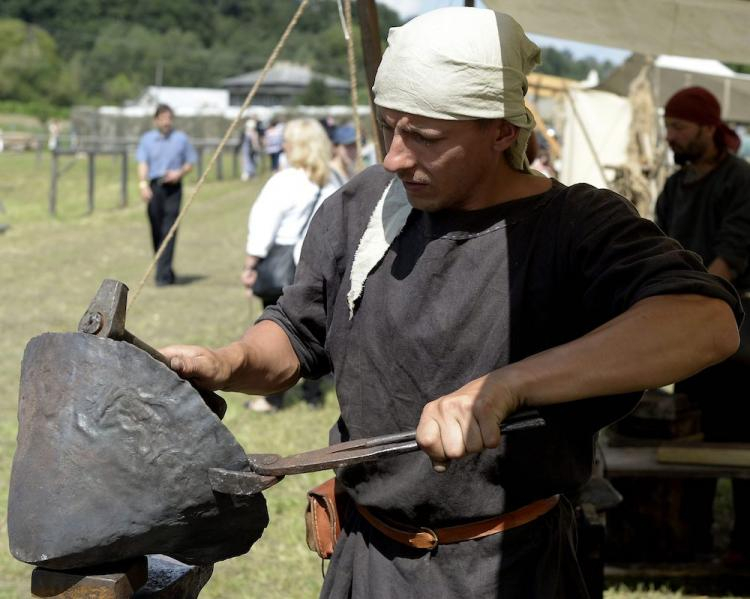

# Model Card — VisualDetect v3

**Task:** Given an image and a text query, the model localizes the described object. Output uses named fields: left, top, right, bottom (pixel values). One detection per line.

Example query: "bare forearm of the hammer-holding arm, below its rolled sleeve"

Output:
left=217, top=320, right=300, bottom=395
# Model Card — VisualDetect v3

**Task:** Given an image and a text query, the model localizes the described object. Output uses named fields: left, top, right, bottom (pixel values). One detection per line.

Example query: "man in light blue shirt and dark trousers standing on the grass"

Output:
left=136, top=104, right=196, bottom=286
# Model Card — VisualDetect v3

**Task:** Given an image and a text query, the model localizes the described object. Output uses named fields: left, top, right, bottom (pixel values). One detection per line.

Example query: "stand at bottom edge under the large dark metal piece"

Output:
left=31, top=555, right=213, bottom=599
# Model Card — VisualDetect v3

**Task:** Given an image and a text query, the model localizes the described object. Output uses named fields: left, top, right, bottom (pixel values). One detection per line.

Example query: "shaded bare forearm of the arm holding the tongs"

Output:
left=500, top=295, right=739, bottom=407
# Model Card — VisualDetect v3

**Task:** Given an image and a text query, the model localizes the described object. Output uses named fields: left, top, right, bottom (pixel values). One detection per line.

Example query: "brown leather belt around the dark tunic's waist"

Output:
left=357, top=495, right=560, bottom=549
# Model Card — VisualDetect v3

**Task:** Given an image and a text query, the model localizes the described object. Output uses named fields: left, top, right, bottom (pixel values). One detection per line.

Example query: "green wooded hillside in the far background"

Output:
left=0, top=0, right=624, bottom=117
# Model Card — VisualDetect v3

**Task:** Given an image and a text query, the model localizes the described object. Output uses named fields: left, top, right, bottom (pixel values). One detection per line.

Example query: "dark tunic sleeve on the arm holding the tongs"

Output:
left=563, top=186, right=742, bottom=328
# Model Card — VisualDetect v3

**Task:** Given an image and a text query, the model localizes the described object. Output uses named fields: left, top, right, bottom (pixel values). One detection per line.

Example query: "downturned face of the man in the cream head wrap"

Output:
left=379, top=108, right=498, bottom=212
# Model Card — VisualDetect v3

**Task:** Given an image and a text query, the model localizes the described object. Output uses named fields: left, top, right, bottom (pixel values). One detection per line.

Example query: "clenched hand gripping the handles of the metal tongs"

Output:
left=417, top=370, right=520, bottom=472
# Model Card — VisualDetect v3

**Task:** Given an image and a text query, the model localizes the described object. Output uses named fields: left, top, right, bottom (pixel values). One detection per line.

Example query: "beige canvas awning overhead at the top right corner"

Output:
left=484, top=0, right=750, bottom=63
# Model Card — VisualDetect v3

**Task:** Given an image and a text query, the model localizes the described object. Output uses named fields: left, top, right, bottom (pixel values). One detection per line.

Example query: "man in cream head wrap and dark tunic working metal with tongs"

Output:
left=164, top=8, right=741, bottom=599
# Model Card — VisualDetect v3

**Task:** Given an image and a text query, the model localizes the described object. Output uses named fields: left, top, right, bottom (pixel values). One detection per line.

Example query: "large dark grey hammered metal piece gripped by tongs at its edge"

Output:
left=8, top=333, right=268, bottom=569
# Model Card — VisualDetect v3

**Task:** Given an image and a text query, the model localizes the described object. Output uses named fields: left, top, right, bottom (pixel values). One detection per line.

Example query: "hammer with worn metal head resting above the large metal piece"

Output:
left=78, top=279, right=227, bottom=418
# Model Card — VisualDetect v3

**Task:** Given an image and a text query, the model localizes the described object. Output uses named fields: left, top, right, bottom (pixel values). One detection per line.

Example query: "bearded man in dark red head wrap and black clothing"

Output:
left=656, top=87, right=750, bottom=566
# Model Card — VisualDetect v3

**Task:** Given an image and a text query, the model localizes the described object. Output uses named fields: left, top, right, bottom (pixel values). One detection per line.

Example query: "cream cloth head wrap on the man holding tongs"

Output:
left=372, top=7, right=540, bottom=169
